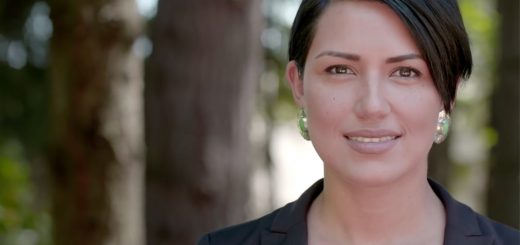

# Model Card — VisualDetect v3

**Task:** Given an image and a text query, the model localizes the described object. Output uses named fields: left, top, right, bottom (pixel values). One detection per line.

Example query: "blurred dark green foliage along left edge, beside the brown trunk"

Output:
left=0, top=0, right=52, bottom=244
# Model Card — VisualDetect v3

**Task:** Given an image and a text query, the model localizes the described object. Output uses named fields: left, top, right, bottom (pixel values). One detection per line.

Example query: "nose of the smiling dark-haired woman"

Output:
left=354, top=79, right=390, bottom=120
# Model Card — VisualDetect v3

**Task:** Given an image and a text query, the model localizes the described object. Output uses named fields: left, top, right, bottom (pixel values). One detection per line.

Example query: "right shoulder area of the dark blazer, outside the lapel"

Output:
left=475, top=213, right=520, bottom=245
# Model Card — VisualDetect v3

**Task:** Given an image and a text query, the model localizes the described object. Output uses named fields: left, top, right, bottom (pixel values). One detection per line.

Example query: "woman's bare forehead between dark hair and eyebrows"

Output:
left=309, top=1, right=419, bottom=55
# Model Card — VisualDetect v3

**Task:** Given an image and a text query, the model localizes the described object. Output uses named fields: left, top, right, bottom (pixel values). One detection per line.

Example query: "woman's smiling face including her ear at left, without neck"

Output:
left=286, top=1, right=442, bottom=185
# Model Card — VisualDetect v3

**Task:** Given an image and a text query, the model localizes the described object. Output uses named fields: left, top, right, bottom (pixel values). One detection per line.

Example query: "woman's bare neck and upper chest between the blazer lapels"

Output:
left=310, top=168, right=445, bottom=244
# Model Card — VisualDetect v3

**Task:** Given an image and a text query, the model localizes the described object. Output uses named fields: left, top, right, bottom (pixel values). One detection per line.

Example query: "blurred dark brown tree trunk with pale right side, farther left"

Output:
left=49, top=0, right=144, bottom=245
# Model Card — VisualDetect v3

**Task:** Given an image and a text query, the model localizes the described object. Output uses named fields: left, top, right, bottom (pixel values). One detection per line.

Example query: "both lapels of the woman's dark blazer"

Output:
left=261, top=179, right=493, bottom=245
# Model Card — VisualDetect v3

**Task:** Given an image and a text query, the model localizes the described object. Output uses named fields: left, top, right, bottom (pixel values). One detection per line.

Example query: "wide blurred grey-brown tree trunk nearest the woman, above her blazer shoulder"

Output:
left=145, top=0, right=262, bottom=245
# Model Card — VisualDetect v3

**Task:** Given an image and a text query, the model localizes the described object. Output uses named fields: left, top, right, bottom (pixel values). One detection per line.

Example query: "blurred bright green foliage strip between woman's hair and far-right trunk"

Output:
left=447, top=0, right=498, bottom=213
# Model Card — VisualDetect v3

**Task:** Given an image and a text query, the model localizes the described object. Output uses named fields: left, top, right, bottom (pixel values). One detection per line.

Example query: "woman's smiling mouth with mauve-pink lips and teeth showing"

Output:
left=344, top=130, right=402, bottom=154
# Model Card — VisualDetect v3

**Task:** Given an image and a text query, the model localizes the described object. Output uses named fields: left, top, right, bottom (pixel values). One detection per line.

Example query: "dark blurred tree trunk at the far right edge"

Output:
left=487, top=0, right=520, bottom=229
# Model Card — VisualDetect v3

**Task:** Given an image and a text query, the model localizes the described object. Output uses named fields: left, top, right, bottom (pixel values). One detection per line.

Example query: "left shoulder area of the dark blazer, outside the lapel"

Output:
left=198, top=206, right=287, bottom=245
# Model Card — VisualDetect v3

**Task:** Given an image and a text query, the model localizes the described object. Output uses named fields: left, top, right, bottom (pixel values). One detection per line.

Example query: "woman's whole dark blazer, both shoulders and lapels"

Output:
left=199, top=180, right=520, bottom=245
